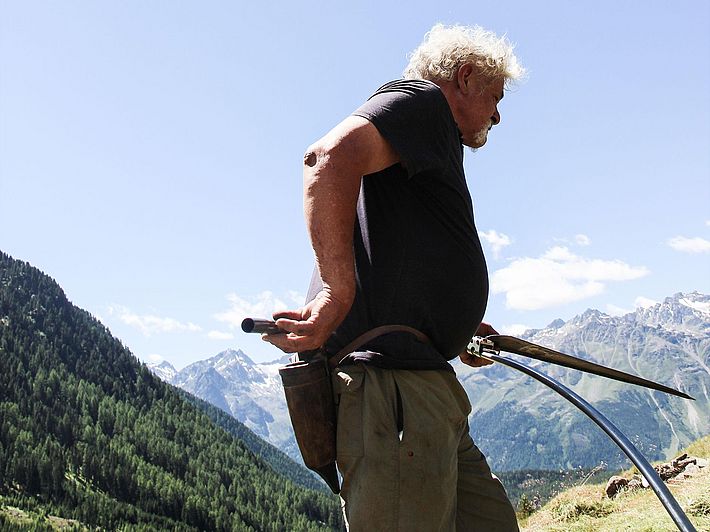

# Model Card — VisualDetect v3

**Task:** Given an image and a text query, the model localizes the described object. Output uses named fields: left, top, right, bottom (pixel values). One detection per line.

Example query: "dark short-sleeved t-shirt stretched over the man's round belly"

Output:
left=309, top=80, right=488, bottom=369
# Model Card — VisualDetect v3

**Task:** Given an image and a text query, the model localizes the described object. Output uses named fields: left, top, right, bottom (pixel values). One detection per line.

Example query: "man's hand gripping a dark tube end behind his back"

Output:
left=261, top=289, right=352, bottom=353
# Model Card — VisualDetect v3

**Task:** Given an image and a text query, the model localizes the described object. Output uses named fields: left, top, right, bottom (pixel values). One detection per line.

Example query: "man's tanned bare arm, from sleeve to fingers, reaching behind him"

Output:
left=264, top=116, right=399, bottom=352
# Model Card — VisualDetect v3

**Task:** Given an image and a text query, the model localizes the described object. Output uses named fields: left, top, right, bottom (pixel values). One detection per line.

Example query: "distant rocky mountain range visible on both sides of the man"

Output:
left=149, top=292, right=710, bottom=471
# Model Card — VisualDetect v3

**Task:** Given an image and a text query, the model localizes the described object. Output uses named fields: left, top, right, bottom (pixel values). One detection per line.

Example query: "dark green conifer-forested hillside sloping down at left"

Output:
left=0, top=252, right=341, bottom=530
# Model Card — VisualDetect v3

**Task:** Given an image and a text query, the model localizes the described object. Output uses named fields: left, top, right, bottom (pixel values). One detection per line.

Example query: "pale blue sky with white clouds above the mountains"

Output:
left=0, top=0, right=710, bottom=368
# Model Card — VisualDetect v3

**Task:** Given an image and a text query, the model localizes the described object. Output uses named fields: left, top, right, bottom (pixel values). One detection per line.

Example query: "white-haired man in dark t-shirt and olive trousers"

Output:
left=264, top=25, right=523, bottom=531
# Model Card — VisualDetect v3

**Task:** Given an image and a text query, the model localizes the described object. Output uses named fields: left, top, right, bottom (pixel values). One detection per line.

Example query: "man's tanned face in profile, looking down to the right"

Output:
left=454, top=78, right=505, bottom=148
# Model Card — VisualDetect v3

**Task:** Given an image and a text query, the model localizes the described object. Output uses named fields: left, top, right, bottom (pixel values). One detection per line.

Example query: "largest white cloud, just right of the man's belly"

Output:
left=491, top=246, right=649, bottom=310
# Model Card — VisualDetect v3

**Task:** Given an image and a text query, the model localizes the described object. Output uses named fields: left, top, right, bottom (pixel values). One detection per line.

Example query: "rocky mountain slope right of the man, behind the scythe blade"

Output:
left=464, top=293, right=710, bottom=469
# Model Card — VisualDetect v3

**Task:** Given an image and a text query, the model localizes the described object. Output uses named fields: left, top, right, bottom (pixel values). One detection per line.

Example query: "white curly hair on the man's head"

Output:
left=404, top=24, right=525, bottom=86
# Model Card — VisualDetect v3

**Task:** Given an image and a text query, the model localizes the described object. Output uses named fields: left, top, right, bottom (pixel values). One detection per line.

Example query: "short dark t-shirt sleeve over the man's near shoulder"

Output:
left=353, top=80, right=458, bottom=177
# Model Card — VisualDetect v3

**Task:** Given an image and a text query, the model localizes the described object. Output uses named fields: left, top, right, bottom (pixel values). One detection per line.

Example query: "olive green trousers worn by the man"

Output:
left=333, top=364, right=518, bottom=532
